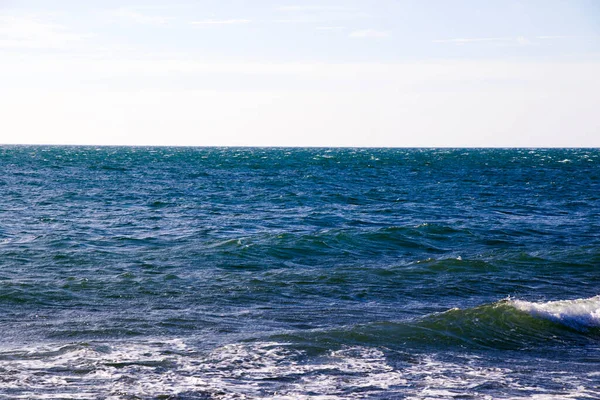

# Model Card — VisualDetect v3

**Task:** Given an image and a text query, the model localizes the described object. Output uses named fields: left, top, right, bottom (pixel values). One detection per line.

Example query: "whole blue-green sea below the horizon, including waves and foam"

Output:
left=0, top=146, right=600, bottom=399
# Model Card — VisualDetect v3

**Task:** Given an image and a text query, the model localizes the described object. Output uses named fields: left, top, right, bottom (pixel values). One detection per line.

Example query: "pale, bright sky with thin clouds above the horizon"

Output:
left=0, top=0, right=600, bottom=147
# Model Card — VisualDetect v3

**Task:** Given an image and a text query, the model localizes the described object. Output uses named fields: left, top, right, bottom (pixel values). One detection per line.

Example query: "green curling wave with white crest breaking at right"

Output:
left=274, top=296, right=600, bottom=351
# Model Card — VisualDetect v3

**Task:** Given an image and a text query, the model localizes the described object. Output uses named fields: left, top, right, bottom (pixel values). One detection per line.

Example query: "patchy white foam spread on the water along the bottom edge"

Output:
left=0, top=340, right=595, bottom=400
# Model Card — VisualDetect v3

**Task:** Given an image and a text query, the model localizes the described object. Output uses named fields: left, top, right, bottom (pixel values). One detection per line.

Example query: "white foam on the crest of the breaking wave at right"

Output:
left=509, top=296, right=600, bottom=330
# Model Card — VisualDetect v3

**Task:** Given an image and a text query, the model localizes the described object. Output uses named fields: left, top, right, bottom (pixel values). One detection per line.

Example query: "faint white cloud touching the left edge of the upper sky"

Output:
left=0, top=15, right=92, bottom=49
